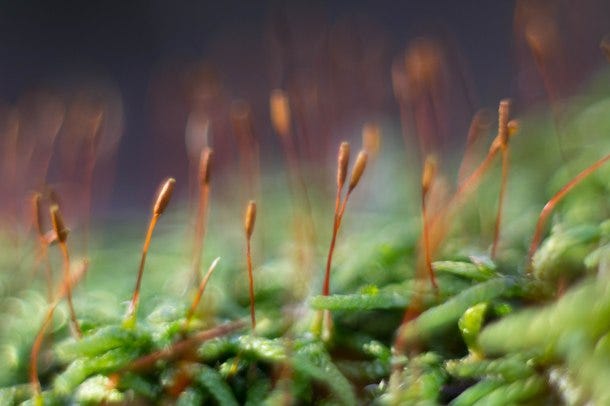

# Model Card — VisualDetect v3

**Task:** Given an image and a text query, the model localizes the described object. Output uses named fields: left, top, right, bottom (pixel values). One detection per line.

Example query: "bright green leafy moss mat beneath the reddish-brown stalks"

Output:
left=0, top=71, right=610, bottom=405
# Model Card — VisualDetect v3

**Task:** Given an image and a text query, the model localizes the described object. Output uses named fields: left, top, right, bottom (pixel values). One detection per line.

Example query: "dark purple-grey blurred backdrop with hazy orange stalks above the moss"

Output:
left=0, top=0, right=610, bottom=230
